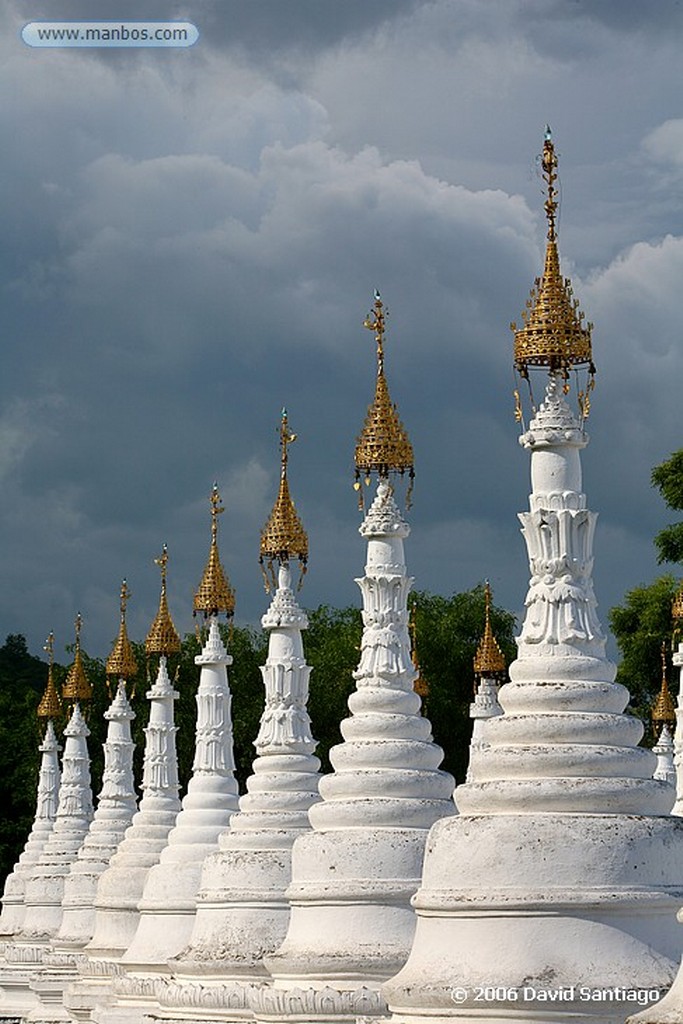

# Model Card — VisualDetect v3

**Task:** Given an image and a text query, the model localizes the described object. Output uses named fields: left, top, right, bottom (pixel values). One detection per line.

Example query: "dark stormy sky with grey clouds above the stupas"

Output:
left=0, top=0, right=683, bottom=662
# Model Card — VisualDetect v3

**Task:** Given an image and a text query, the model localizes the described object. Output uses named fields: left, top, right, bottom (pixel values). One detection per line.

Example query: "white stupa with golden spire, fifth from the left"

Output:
left=117, top=503, right=238, bottom=983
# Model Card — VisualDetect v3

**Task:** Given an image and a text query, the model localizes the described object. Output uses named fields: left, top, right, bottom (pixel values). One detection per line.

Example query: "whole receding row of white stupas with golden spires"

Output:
left=0, top=133, right=683, bottom=1024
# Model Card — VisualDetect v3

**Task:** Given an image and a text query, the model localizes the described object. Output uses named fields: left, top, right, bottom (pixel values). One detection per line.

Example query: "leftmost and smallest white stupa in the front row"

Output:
left=0, top=633, right=61, bottom=939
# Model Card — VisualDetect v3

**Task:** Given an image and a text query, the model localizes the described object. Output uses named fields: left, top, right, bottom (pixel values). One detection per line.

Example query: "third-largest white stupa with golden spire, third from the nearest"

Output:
left=161, top=411, right=321, bottom=1020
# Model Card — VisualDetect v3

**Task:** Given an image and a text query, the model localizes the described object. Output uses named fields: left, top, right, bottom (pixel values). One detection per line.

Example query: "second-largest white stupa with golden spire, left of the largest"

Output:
left=259, top=294, right=456, bottom=1021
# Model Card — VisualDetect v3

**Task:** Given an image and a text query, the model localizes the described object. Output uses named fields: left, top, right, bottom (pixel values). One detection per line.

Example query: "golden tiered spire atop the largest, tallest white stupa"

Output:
left=510, top=127, right=595, bottom=419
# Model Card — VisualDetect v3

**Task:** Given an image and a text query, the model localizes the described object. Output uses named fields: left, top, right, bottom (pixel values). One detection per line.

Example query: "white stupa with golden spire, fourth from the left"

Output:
left=65, top=561, right=180, bottom=1021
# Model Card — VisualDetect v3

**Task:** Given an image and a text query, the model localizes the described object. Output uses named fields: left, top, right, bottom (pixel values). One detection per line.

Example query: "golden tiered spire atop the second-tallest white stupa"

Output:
left=353, top=291, right=415, bottom=508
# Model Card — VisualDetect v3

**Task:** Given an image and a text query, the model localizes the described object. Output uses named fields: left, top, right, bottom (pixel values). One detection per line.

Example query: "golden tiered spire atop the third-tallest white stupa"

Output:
left=259, top=409, right=308, bottom=592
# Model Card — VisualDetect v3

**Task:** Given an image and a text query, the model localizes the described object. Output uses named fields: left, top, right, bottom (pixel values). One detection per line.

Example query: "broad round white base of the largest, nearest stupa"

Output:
left=384, top=813, right=683, bottom=1024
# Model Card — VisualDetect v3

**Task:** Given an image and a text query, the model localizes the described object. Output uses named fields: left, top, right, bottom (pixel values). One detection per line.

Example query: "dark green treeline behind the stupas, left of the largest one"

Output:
left=0, top=586, right=515, bottom=879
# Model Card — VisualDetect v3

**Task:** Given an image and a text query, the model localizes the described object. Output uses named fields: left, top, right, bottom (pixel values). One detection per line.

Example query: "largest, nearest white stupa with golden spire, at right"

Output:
left=384, top=128, right=683, bottom=1024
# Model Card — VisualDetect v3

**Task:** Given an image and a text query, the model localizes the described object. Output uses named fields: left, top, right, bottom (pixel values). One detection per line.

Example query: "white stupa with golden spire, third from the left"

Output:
left=53, top=580, right=137, bottom=952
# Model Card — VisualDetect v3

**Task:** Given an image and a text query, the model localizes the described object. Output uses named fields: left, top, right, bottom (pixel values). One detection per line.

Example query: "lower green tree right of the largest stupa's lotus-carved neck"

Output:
left=609, top=575, right=676, bottom=746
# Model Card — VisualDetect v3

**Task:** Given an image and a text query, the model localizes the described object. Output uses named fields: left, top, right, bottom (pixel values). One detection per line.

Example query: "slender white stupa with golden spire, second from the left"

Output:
left=18, top=614, right=92, bottom=944
